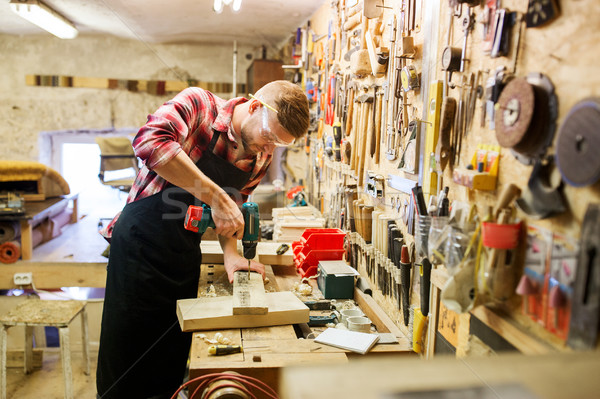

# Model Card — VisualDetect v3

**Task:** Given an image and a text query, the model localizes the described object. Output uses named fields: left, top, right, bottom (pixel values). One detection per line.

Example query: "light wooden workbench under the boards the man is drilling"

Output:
left=190, top=264, right=415, bottom=396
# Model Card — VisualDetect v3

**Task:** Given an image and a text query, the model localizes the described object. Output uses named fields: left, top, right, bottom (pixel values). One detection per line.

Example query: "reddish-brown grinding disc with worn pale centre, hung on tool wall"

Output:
left=495, top=78, right=535, bottom=148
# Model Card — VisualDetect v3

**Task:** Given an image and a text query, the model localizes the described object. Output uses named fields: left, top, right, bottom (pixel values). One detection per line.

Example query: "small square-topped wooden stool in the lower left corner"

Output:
left=0, top=299, right=90, bottom=399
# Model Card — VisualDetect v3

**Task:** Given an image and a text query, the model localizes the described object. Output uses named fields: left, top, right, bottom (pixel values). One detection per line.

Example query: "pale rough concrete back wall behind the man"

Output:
left=0, top=35, right=255, bottom=161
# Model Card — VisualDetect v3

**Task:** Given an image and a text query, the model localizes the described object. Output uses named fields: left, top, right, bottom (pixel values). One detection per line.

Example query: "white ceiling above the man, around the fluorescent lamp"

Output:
left=0, top=0, right=327, bottom=49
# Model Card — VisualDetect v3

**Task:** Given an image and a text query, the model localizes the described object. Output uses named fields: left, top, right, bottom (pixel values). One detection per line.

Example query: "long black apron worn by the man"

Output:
left=96, top=131, right=251, bottom=399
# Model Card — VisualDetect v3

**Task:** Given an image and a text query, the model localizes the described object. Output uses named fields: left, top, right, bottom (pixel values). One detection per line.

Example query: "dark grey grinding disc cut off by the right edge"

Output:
left=556, top=98, right=600, bottom=187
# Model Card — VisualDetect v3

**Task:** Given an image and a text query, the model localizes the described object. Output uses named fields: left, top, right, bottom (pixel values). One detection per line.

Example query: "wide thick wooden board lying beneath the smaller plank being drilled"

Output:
left=177, top=291, right=309, bottom=331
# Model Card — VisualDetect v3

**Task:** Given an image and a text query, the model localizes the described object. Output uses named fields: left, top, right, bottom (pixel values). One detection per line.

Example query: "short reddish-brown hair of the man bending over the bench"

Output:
left=256, top=80, right=310, bottom=138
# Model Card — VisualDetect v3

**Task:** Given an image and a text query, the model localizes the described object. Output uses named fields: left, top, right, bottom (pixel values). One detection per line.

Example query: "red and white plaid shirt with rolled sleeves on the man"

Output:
left=100, top=87, right=272, bottom=241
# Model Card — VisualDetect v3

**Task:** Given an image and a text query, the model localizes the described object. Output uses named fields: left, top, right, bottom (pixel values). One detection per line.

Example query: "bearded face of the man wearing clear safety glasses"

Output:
left=240, top=102, right=294, bottom=155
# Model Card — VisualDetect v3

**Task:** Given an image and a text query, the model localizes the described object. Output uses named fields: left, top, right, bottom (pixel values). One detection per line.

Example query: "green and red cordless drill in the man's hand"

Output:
left=183, top=202, right=260, bottom=274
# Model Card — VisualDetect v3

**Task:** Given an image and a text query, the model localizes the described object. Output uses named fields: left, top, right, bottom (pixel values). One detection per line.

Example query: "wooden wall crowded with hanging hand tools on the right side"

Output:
left=292, top=0, right=600, bottom=355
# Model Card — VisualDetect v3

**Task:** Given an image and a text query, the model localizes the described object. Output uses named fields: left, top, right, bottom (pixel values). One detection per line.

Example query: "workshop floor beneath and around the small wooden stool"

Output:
left=6, top=345, right=98, bottom=399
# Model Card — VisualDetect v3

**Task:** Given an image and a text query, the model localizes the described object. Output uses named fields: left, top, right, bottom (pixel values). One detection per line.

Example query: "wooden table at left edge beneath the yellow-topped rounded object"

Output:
left=0, top=194, right=78, bottom=260
